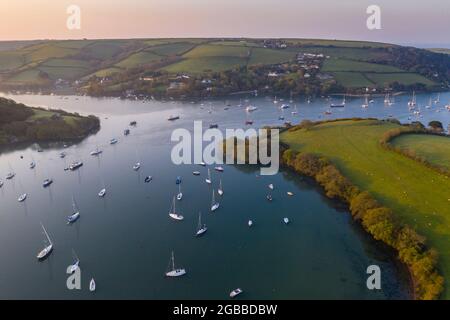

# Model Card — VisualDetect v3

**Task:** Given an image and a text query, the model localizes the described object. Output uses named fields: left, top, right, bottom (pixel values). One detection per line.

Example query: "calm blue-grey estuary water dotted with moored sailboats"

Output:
left=0, top=90, right=450, bottom=299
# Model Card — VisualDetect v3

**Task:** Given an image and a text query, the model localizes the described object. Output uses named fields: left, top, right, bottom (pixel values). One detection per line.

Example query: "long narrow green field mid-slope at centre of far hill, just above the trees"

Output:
left=163, top=57, right=247, bottom=73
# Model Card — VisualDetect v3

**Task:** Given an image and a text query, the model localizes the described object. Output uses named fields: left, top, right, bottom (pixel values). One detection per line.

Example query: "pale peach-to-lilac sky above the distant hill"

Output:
left=0, top=0, right=450, bottom=47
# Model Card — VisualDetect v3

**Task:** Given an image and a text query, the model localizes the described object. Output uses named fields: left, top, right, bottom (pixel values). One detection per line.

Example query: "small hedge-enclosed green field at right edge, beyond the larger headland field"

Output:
left=391, top=134, right=450, bottom=170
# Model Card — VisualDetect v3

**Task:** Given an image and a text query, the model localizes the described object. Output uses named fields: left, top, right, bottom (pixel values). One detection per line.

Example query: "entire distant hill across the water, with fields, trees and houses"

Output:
left=0, top=38, right=450, bottom=95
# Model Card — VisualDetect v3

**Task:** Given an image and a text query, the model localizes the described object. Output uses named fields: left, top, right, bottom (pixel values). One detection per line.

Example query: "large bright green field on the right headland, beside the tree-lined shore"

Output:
left=281, top=120, right=450, bottom=299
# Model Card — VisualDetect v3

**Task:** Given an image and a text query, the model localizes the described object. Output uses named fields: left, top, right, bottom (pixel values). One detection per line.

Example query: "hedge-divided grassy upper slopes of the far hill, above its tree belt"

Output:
left=0, top=39, right=450, bottom=91
